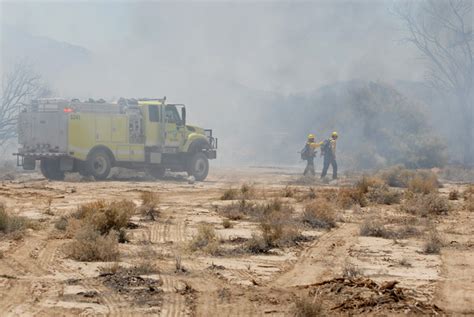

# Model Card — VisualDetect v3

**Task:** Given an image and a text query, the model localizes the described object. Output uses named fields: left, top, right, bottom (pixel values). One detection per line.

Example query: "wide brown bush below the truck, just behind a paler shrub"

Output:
left=73, top=200, right=135, bottom=235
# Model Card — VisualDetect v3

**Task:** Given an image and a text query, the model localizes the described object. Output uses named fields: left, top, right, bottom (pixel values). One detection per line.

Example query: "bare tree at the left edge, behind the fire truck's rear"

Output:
left=0, top=61, right=50, bottom=147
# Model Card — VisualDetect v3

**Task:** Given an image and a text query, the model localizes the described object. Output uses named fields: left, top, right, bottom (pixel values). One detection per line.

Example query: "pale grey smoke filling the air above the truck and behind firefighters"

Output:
left=2, top=1, right=462, bottom=168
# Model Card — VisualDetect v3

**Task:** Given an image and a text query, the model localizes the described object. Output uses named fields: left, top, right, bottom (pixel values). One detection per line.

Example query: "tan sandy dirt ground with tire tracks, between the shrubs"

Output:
left=0, top=168, right=474, bottom=316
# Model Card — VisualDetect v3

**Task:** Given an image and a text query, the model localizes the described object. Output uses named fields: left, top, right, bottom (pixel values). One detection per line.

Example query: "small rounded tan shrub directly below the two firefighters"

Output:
left=302, top=199, right=336, bottom=228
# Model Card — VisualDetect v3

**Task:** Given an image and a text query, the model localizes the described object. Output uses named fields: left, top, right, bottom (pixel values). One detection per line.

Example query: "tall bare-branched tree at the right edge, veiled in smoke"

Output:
left=395, top=0, right=474, bottom=165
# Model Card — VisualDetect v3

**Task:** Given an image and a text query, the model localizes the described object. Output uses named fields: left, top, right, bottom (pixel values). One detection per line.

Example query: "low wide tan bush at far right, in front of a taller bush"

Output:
left=401, top=193, right=449, bottom=217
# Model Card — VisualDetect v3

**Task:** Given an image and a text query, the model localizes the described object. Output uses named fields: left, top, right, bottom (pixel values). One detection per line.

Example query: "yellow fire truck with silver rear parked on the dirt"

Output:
left=15, top=97, right=217, bottom=181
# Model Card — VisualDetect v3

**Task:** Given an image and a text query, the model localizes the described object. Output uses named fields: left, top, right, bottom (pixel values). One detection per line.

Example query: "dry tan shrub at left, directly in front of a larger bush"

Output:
left=68, top=225, right=119, bottom=261
